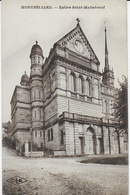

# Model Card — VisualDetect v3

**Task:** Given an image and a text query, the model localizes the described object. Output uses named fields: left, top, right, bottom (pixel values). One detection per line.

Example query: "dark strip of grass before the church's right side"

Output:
left=80, top=155, right=128, bottom=165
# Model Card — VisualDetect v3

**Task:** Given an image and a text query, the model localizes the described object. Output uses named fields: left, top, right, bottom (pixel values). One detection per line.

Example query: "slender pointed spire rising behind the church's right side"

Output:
left=102, top=27, right=114, bottom=86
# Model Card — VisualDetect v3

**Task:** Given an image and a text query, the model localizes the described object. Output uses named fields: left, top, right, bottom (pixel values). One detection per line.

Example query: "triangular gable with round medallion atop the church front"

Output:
left=57, top=24, right=100, bottom=64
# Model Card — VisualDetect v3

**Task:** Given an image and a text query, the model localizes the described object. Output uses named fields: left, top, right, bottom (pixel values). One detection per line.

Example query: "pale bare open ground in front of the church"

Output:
left=3, top=146, right=128, bottom=195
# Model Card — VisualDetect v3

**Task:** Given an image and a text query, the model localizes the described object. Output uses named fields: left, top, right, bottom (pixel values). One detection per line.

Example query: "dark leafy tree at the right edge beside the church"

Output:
left=114, top=76, right=128, bottom=131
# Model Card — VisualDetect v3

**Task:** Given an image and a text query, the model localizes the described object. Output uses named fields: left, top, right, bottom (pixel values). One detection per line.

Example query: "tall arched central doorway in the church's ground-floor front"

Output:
left=86, top=127, right=96, bottom=154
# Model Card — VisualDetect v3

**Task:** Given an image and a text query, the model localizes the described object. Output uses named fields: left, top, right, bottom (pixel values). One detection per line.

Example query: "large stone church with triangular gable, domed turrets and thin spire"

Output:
left=11, top=19, right=127, bottom=156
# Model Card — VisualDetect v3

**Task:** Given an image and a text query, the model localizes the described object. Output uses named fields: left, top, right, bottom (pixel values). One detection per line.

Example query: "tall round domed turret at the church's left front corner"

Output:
left=30, top=41, right=44, bottom=147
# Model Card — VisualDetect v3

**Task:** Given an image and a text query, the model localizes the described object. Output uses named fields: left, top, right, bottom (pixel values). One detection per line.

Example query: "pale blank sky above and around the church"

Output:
left=1, top=0, right=127, bottom=122
